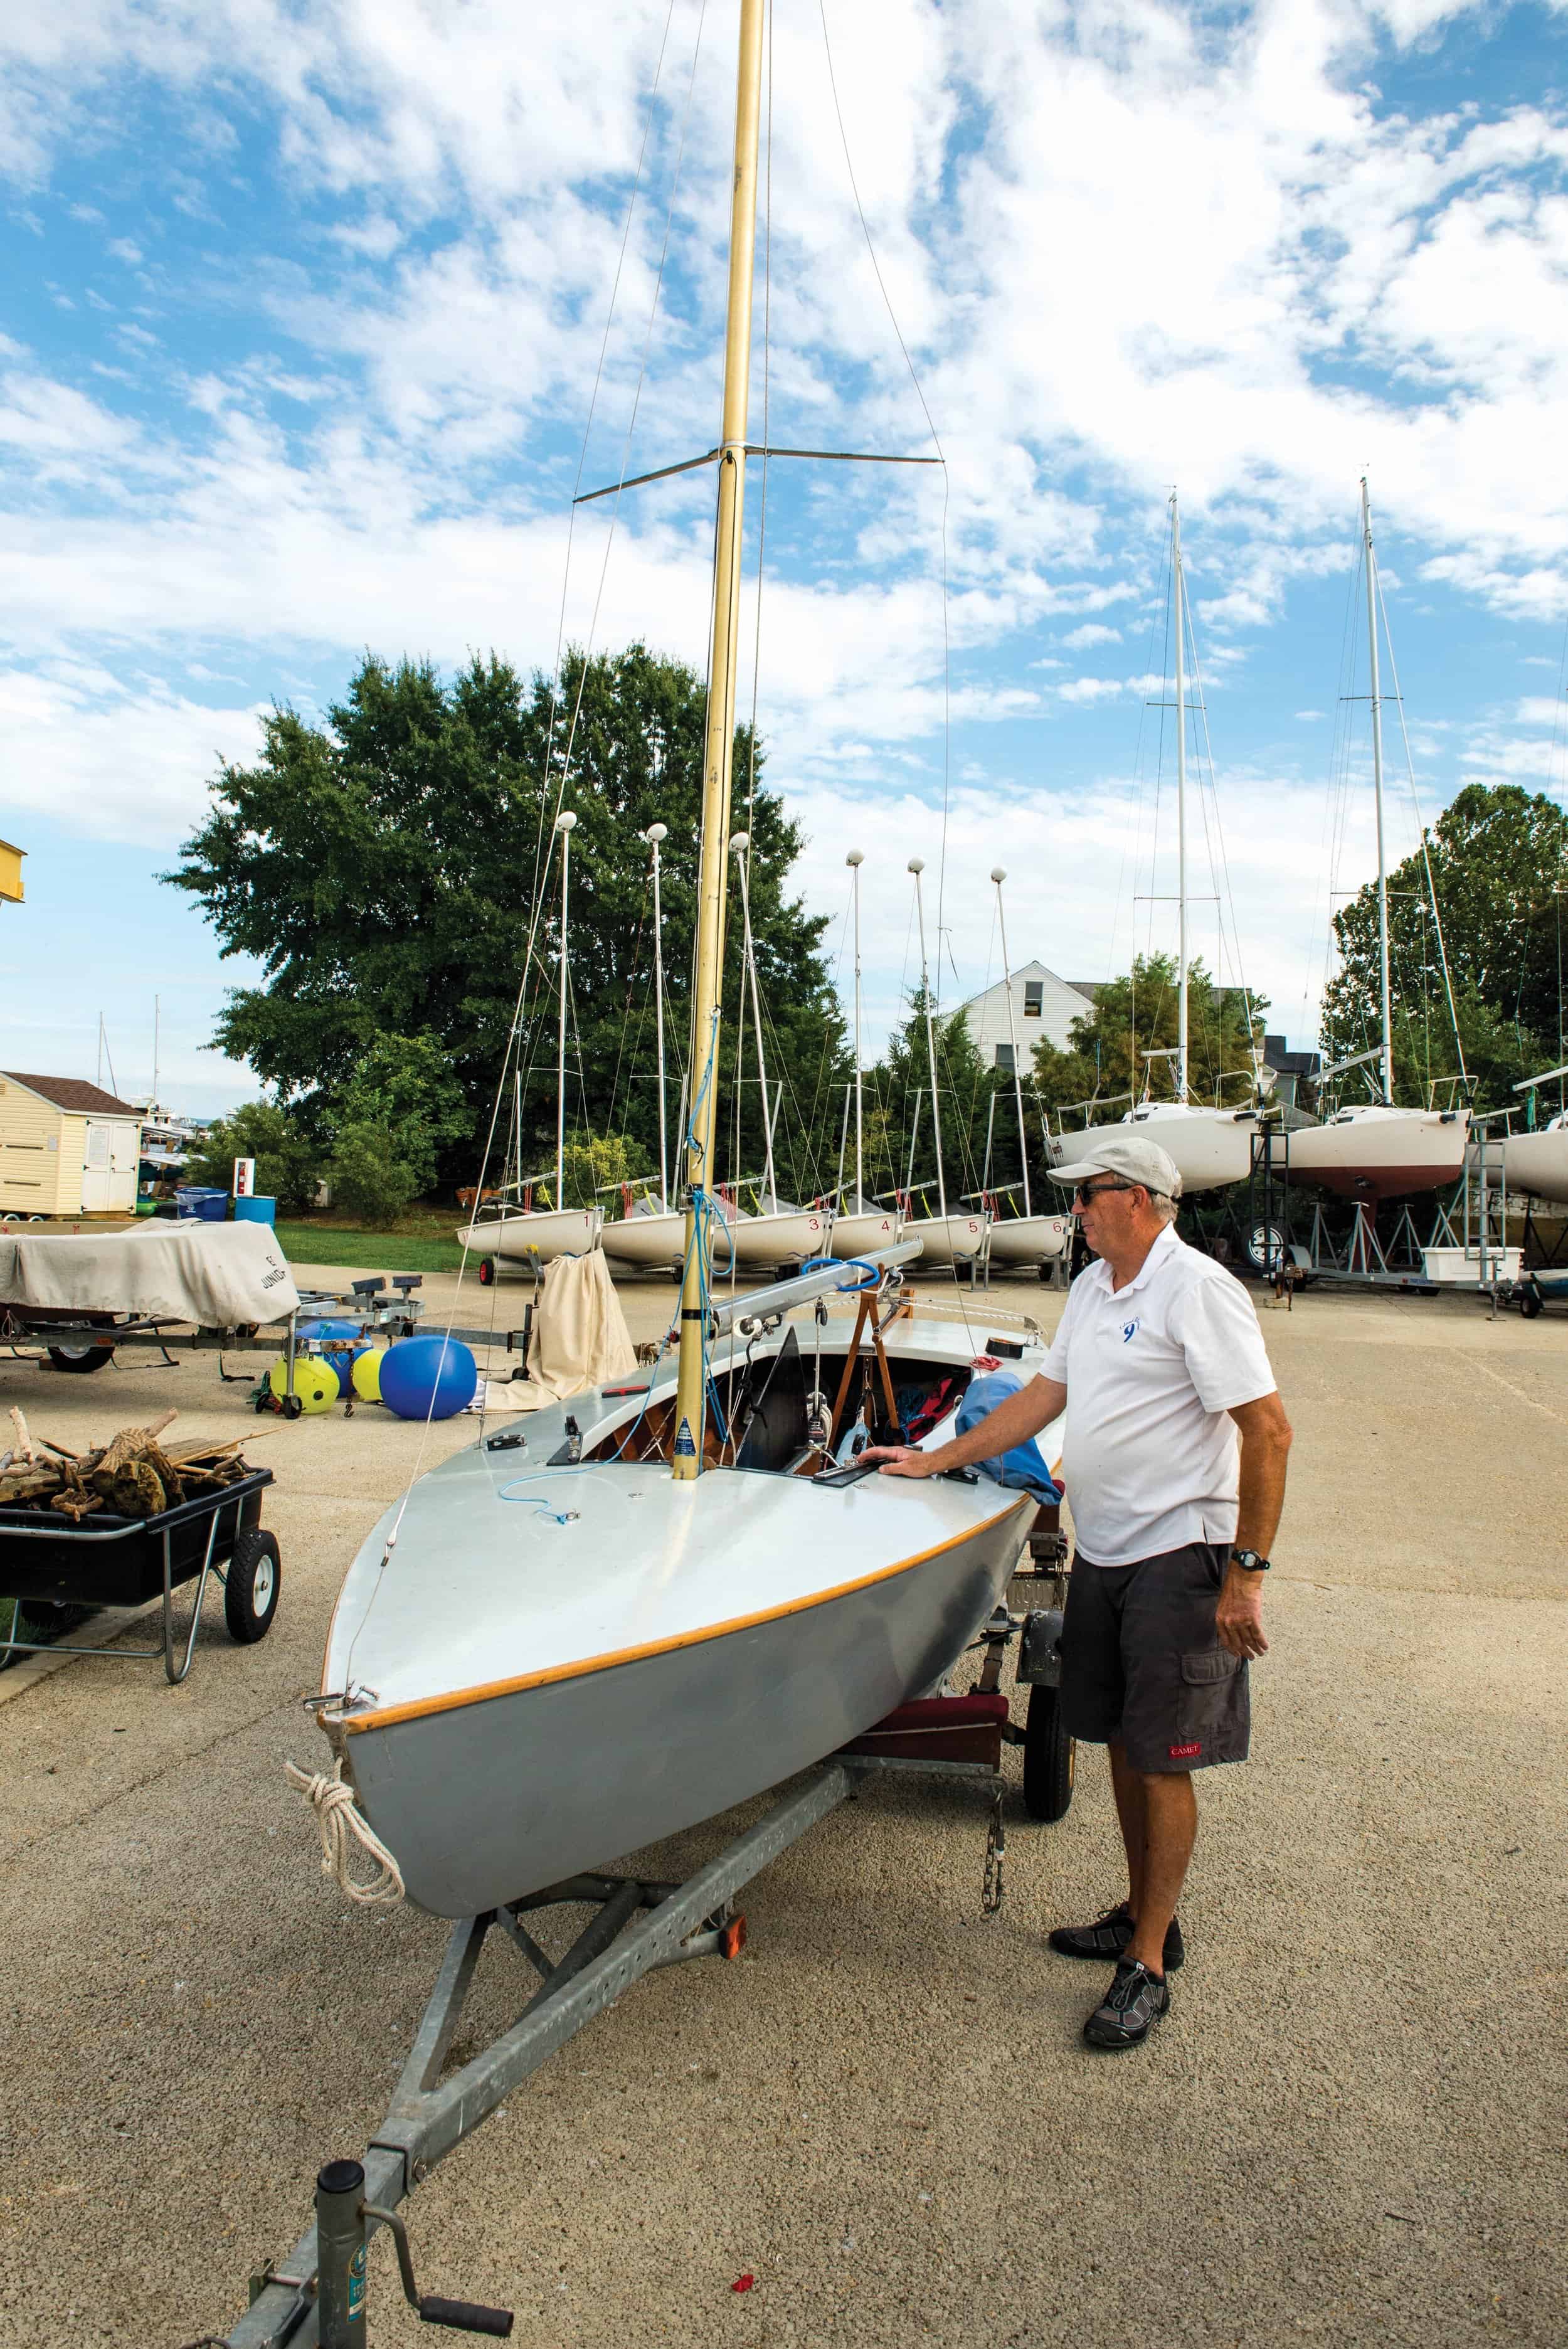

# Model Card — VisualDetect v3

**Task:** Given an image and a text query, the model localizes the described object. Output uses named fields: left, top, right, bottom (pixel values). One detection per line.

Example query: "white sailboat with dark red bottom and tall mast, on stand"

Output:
left=1289, top=479, right=1470, bottom=1212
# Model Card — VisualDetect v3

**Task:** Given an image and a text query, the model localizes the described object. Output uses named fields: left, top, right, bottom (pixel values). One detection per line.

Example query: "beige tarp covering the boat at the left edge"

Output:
left=0, top=1217, right=300, bottom=1330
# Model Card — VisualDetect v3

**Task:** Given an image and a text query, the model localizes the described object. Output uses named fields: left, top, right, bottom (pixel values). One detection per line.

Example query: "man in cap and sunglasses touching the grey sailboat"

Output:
left=864, top=1128, right=1291, bottom=2049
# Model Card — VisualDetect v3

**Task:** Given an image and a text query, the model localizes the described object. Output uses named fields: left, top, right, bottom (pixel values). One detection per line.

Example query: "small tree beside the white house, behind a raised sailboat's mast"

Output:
left=1035, top=953, right=1268, bottom=1123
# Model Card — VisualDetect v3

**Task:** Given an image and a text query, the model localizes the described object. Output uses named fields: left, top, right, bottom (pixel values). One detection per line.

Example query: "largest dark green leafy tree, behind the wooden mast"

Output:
left=169, top=644, right=843, bottom=1189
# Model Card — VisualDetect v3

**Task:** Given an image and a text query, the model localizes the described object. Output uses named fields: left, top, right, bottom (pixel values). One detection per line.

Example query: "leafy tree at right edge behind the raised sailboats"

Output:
left=1324, top=782, right=1568, bottom=1109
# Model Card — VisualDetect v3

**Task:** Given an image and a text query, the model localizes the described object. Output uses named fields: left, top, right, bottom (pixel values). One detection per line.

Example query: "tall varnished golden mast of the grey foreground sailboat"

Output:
left=671, top=0, right=765, bottom=1482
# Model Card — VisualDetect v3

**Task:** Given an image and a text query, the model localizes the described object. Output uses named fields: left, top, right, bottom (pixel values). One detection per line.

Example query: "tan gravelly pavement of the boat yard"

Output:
left=0, top=1271, right=1568, bottom=2349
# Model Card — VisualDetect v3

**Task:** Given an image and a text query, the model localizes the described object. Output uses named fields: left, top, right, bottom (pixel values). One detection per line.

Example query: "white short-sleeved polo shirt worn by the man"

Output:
left=1044, top=1224, right=1274, bottom=1567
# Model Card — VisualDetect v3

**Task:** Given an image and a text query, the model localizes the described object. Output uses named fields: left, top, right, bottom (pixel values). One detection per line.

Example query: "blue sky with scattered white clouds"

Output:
left=0, top=0, right=1568, bottom=1113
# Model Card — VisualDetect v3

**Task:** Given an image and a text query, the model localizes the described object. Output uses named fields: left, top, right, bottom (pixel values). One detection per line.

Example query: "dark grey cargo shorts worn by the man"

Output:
left=1061, top=1541, right=1251, bottom=1771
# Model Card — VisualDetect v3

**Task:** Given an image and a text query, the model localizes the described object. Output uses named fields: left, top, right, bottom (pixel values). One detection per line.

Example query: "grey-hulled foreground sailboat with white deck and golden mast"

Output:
left=314, top=0, right=1054, bottom=1917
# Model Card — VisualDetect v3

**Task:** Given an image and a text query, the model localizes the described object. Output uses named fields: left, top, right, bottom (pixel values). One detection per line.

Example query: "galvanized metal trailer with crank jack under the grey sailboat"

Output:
left=211, top=1609, right=1059, bottom=2349
